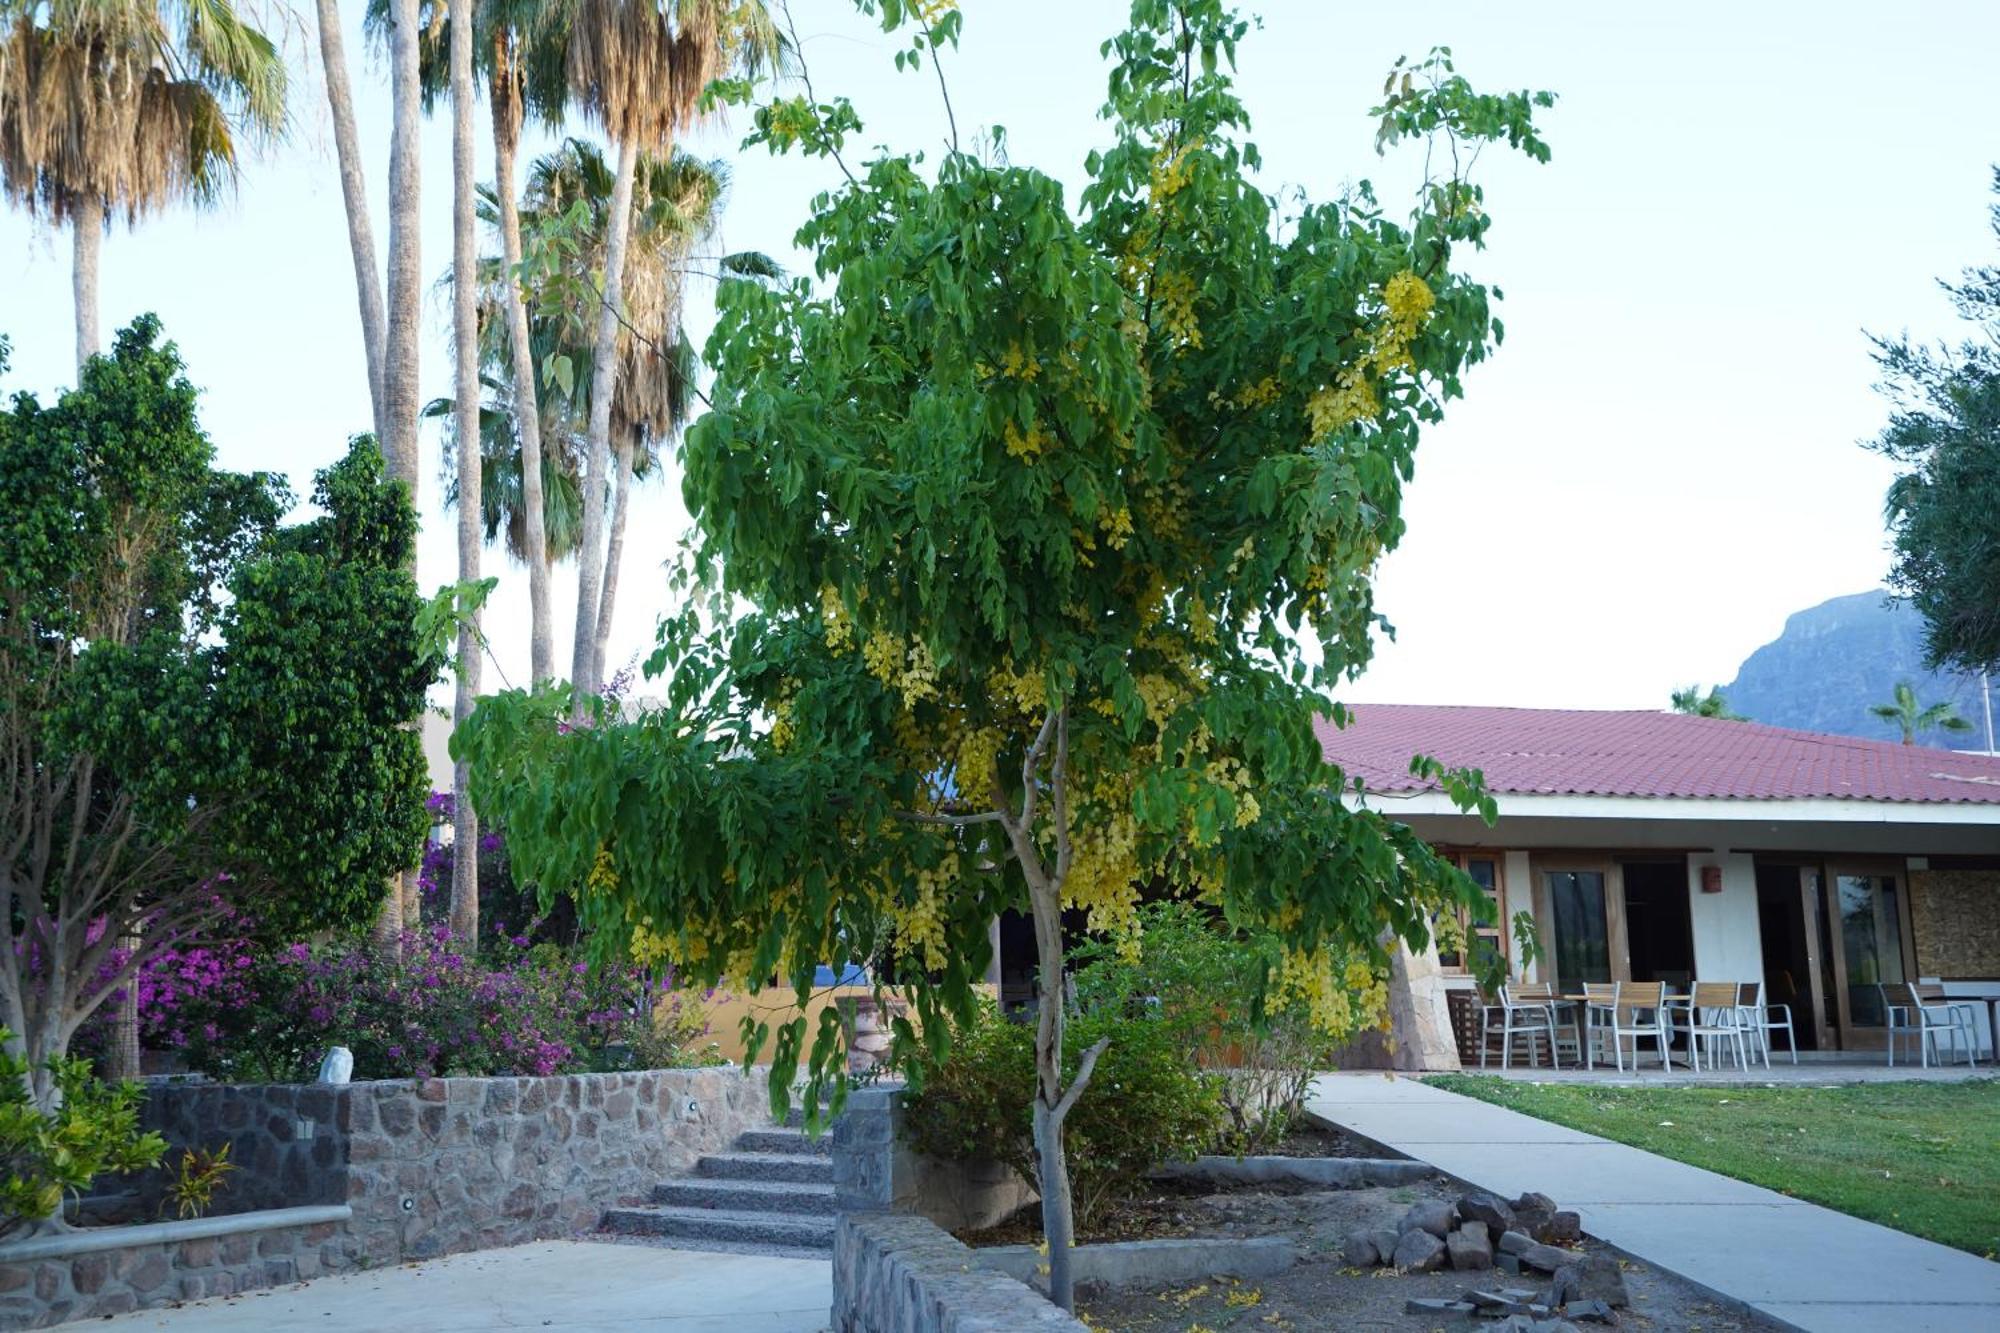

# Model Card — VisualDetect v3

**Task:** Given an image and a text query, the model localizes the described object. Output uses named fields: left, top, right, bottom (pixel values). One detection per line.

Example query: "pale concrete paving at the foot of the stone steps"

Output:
left=92, top=1241, right=834, bottom=1333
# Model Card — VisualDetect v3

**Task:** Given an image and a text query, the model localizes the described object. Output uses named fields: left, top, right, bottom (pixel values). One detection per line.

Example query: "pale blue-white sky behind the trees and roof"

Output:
left=0, top=0, right=2000, bottom=709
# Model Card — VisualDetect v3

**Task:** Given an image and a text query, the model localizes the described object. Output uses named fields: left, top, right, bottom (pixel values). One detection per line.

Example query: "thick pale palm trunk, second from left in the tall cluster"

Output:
left=382, top=0, right=424, bottom=492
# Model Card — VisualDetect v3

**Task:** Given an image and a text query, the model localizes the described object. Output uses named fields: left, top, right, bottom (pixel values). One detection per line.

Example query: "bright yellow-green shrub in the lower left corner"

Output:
left=0, top=1027, right=166, bottom=1237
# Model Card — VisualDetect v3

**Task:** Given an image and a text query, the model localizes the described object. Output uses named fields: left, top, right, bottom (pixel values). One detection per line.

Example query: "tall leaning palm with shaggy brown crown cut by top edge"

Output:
left=564, top=0, right=780, bottom=713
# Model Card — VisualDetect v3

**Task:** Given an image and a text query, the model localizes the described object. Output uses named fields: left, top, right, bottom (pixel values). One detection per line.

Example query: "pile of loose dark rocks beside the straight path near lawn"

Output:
left=1344, top=1191, right=1628, bottom=1333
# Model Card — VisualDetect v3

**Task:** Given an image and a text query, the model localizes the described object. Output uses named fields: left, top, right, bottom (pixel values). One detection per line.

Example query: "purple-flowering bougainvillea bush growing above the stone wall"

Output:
left=182, top=927, right=712, bottom=1081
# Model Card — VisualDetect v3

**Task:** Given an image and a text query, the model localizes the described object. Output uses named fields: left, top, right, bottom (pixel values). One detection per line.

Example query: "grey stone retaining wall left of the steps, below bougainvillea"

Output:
left=0, top=1067, right=770, bottom=1329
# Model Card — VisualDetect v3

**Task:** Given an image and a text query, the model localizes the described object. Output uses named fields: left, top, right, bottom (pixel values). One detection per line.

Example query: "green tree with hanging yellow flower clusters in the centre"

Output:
left=454, top=0, right=1550, bottom=1303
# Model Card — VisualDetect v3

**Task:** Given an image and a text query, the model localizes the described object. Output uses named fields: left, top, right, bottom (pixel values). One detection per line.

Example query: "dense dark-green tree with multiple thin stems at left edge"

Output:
left=0, top=316, right=442, bottom=1109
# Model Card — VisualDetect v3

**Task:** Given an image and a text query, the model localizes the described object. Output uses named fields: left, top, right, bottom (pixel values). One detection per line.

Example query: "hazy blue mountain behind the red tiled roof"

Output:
left=1722, top=588, right=1986, bottom=749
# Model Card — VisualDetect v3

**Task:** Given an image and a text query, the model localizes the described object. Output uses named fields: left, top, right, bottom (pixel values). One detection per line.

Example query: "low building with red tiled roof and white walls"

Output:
left=1320, top=705, right=2000, bottom=1051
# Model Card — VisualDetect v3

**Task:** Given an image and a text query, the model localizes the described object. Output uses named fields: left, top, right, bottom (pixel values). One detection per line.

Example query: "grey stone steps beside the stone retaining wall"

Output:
left=602, top=1113, right=834, bottom=1259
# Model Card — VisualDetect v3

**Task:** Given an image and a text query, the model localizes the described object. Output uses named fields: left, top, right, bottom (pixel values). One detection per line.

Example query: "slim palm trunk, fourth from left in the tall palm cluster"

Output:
left=492, top=46, right=556, bottom=685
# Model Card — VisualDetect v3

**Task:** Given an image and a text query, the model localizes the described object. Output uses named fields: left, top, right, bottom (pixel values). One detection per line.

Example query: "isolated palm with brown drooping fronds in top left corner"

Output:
left=0, top=0, right=286, bottom=368
